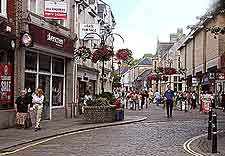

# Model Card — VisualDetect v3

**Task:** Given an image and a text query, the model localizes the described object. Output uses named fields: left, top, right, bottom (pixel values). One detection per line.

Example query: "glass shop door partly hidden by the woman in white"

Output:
left=39, top=74, right=50, bottom=120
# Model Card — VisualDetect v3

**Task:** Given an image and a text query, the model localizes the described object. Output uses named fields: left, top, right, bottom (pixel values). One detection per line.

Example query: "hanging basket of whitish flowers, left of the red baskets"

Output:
left=74, top=46, right=91, bottom=61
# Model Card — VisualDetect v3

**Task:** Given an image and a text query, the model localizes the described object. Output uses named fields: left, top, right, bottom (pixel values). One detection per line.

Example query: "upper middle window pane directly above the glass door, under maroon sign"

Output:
left=39, top=54, right=51, bottom=72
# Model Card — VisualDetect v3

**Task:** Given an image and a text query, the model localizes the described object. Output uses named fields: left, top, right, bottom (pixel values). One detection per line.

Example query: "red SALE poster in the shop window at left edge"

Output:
left=0, top=64, right=13, bottom=103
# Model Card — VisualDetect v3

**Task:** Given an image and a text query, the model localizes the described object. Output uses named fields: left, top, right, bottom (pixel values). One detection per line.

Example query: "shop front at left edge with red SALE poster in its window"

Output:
left=0, top=22, right=16, bottom=129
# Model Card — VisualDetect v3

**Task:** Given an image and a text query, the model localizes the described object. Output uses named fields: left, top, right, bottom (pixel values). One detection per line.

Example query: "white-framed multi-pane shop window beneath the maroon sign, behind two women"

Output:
left=25, top=51, right=65, bottom=108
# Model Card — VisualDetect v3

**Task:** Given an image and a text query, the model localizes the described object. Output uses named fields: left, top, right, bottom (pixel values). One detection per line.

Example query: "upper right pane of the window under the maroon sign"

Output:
left=52, top=57, right=64, bottom=75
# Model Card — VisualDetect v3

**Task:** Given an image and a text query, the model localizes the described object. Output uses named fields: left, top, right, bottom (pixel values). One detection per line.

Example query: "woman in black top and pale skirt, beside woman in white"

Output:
left=15, top=90, right=30, bottom=128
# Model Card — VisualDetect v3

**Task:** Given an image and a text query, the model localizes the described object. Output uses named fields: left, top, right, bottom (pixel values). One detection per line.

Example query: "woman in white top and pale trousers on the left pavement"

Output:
left=32, top=88, right=44, bottom=131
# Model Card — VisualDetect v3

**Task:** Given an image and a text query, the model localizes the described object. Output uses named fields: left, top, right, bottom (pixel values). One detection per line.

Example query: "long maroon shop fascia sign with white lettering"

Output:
left=29, top=24, right=73, bottom=54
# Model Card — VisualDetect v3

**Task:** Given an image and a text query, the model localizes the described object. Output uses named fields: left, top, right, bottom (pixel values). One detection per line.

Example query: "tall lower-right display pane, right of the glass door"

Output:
left=52, top=77, right=63, bottom=106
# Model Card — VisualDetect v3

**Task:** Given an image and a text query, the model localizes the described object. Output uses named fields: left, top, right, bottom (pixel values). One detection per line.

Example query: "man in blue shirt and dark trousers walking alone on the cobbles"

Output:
left=164, top=85, right=174, bottom=118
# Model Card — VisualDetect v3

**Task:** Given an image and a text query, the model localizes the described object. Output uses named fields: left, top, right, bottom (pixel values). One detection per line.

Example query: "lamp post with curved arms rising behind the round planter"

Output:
left=83, top=29, right=124, bottom=93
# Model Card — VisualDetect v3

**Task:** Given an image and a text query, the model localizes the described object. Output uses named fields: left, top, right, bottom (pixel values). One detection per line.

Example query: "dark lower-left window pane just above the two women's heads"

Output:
left=25, top=73, right=37, bottom=92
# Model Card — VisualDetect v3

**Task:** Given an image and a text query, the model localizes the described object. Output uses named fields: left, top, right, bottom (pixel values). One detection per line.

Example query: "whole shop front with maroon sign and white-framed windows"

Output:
left=21, top=24, right=73, bottom=119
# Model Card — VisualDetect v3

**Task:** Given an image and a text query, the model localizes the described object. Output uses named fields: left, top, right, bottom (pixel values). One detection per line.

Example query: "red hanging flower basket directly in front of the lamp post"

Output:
left=91, top=46, right=114, bottom=63
